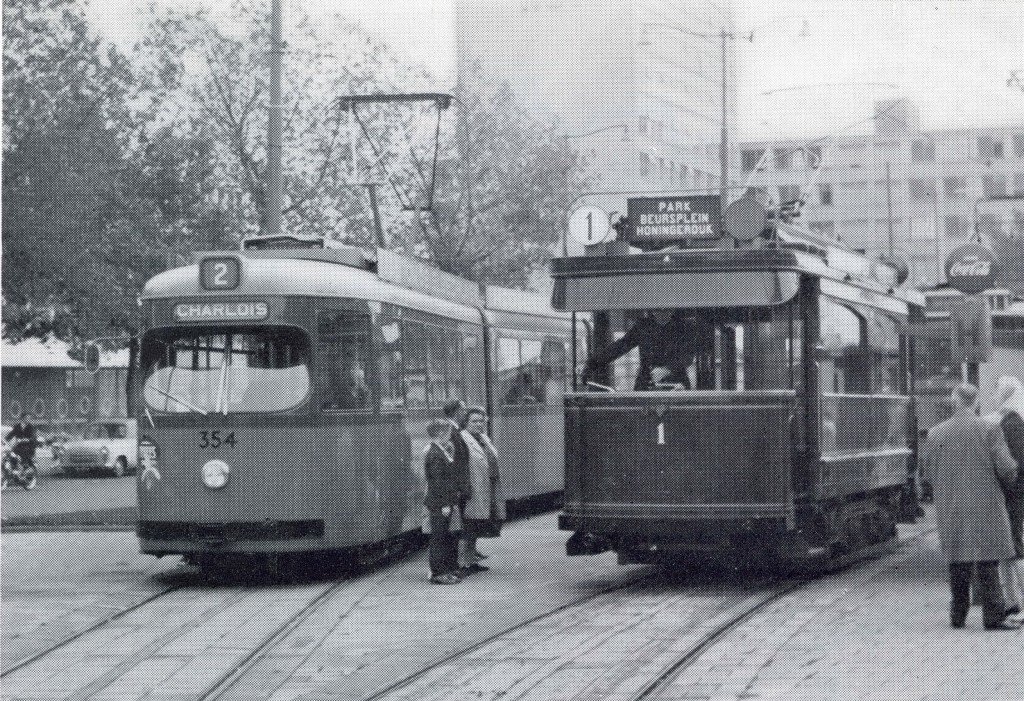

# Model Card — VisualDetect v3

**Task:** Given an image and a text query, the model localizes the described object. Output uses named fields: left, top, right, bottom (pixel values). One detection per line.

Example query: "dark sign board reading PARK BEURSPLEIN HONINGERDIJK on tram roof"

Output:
left=624, top=194, right=722, bottom=243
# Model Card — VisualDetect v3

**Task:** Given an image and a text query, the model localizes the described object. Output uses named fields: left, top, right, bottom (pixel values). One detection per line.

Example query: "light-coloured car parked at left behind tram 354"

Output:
left=53, top=419, right=138, bottom=477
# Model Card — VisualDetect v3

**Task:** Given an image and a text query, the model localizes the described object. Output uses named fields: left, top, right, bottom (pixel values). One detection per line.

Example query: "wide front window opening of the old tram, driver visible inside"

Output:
left=582, top=304, right=803, bottom=391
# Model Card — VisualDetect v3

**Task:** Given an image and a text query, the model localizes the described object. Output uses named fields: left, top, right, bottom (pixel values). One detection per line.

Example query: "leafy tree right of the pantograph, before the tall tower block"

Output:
left=409, top=68, right=590, bottom=287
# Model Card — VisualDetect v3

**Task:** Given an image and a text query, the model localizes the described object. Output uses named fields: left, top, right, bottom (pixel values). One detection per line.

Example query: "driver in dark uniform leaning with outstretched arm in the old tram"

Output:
left=583, top=309, right=710, bottom=390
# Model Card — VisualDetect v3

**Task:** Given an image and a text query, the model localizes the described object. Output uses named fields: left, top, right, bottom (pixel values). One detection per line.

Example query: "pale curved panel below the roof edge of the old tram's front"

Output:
left=552, top=270, right=800, bottom=311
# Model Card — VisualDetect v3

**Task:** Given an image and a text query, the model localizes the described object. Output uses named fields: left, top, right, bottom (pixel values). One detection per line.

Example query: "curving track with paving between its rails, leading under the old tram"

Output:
left=356, top=535, right=920, bottom=701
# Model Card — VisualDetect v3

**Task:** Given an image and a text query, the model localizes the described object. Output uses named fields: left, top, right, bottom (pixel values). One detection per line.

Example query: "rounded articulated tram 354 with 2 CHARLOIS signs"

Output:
left=135, top=235, right=586, bottom=565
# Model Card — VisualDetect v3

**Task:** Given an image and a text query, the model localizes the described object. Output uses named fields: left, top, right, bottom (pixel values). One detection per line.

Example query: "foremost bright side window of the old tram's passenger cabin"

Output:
left=818, top=297, right=871, bottom=394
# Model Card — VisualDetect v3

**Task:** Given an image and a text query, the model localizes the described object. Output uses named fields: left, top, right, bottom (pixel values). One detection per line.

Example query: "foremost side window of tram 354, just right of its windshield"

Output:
left=319, top=312, right=371, bottom=410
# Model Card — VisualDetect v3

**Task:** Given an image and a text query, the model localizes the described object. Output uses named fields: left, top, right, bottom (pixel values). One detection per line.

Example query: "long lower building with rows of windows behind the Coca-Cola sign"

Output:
left=739, top=99, right=1024, bottom=287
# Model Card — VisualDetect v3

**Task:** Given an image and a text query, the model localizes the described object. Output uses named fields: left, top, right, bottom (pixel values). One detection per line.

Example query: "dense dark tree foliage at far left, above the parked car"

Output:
left=3, top=0, right=229, bottom=340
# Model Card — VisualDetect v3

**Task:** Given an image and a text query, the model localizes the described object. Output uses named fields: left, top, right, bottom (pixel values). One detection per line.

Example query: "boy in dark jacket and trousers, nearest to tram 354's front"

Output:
left=423, top=419, right=462, bottom=584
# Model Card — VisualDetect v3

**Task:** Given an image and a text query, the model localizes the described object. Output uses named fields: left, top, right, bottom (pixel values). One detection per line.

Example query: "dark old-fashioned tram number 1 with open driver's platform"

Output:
left=552, top=198, right=924, bottom=563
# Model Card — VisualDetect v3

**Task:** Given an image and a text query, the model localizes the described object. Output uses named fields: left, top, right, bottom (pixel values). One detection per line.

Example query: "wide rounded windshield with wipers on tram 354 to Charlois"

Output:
left=141, top=326, right=309, bottom=413
